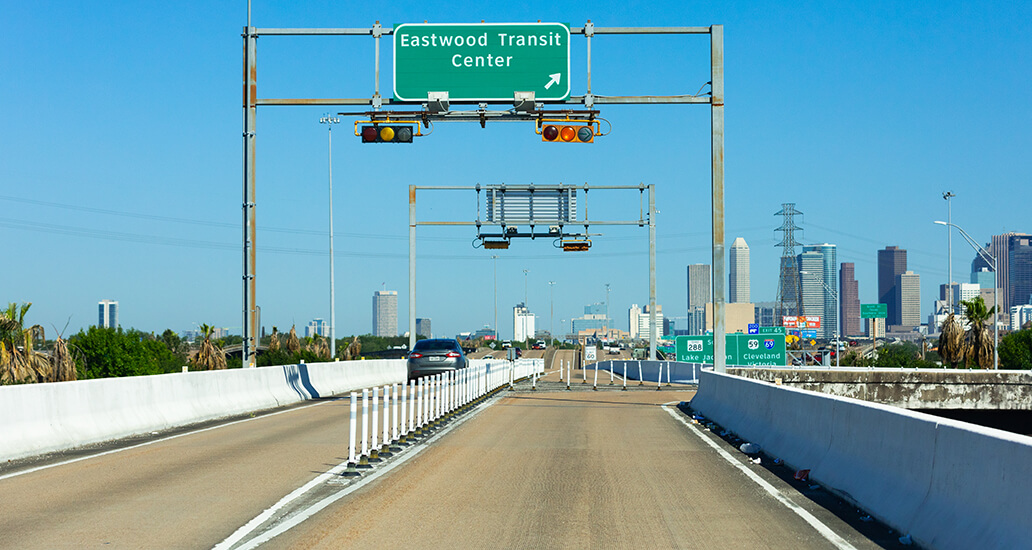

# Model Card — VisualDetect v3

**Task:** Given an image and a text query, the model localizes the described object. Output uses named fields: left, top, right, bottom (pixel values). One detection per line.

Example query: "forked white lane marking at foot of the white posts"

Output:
left=212, top=394, right=504, bottom=550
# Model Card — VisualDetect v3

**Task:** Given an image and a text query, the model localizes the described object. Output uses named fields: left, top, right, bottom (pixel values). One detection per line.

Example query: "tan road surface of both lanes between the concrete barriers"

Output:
left=0, top=365, right=877, bottom=548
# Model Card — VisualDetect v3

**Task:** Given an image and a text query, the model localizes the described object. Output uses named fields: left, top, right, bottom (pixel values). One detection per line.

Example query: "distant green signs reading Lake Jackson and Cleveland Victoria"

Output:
left=674, top=333, right=787, bottom=366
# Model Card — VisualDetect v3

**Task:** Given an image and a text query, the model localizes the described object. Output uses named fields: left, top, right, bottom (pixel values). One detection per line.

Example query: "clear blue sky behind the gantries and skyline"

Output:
left=0, top=1, right=1032, bottom=336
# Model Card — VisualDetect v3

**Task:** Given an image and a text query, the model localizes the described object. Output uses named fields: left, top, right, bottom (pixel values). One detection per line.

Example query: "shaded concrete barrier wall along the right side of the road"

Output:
left=691, top=370, right=1032, bottom=549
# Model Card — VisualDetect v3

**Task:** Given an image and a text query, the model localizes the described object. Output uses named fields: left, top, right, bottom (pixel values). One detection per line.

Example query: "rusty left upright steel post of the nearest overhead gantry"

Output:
left=241, top=26, right=258, bottom=367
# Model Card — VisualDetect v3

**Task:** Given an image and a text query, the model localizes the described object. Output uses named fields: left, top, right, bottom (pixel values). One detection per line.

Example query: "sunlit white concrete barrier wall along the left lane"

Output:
left=0, top=359, right=407, bottom=460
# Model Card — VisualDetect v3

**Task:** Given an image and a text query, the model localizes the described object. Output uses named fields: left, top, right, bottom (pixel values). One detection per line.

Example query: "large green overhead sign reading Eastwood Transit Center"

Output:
left=394, top=23, right=570, bottom=101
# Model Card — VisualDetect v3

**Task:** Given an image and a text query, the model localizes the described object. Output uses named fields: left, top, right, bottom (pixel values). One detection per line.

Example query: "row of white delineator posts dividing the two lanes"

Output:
left=344, top=360, right=540, bottom=477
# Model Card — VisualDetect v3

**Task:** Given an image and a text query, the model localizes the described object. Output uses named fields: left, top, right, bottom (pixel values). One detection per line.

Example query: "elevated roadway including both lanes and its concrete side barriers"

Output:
left=0, top=351, right=1032, bottom=548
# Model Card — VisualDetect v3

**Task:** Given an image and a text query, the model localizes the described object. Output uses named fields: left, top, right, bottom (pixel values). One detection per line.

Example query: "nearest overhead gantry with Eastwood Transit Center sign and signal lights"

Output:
left=243, top=15, right=727, bottom=371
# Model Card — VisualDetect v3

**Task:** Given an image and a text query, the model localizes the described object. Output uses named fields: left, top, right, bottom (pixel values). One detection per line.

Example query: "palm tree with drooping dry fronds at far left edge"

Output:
left=0, top=302, right=51, bottom=384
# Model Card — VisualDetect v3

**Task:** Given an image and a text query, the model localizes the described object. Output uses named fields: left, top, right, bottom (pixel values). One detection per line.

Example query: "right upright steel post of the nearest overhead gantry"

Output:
left=710, top=25, right=728, bottom=373
